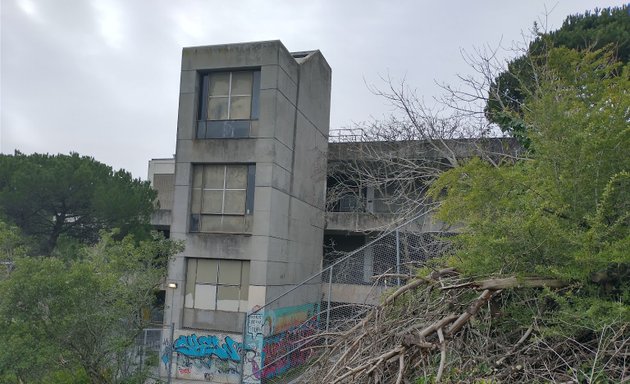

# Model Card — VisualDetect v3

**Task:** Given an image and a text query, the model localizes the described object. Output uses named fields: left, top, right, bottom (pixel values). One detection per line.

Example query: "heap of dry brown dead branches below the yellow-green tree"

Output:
left=300, top=269, right=630, bottom=384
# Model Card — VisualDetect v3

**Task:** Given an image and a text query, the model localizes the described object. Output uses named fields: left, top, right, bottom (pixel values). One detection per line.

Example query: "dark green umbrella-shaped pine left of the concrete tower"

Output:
left=0, top=152, right=156, bottom=254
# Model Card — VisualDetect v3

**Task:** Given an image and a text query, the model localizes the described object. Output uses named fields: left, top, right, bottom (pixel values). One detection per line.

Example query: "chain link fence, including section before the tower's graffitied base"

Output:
left=138, top=214, right=447, bottom=384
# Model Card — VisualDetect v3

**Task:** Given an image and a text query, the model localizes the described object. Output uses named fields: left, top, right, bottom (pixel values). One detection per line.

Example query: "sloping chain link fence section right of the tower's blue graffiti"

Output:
left=241, top=214, right=447, bottom=384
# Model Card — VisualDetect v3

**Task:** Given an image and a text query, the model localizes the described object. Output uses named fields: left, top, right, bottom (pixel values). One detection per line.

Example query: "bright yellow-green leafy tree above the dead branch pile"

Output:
left=432, top=48, right=630, bottom=281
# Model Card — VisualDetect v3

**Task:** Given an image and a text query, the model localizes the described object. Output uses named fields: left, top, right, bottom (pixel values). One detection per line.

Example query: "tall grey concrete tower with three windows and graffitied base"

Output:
left=156, top=41, right=331, bottom=383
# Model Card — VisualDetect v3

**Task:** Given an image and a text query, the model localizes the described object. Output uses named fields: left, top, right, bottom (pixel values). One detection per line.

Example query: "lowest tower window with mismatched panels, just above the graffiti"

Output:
left=184, top=258, right=249, bottom=312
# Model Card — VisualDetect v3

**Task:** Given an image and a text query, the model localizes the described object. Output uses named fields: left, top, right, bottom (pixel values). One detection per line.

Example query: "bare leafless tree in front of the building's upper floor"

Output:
left=326, top=79, right=521, bottom=230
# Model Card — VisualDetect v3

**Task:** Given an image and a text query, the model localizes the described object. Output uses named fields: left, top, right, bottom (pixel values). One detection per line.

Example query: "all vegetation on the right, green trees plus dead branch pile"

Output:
left=304, top=7, right=630, bottom=384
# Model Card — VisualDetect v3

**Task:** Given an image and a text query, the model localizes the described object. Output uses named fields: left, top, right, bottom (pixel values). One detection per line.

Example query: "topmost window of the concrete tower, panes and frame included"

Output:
left=197, top=71, right=260, bottom=139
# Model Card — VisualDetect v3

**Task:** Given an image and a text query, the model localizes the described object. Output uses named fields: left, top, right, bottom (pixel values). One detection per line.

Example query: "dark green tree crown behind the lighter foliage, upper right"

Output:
left=485, top=5, right=630, bottom=143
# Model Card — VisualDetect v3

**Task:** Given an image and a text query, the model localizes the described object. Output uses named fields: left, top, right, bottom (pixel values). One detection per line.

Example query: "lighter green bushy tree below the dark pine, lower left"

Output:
left=0, top=228, right=181, bottom=384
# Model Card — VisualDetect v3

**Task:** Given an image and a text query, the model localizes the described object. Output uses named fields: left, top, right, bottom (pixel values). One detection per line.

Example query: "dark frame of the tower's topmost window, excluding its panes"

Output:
left=195, top=68, right=261, bottom=139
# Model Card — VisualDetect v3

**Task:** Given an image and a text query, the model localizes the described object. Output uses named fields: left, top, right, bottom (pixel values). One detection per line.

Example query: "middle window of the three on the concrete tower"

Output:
left=190, top=164, right=256, bottom=233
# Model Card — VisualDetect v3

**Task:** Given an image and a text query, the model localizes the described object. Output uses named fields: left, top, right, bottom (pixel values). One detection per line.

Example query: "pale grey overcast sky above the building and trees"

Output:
left=0, top=0, right=624, bottom=179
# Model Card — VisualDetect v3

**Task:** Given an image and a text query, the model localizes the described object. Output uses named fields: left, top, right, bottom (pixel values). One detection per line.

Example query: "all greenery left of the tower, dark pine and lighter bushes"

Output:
left=0, top=153, right=181, bottom=384
